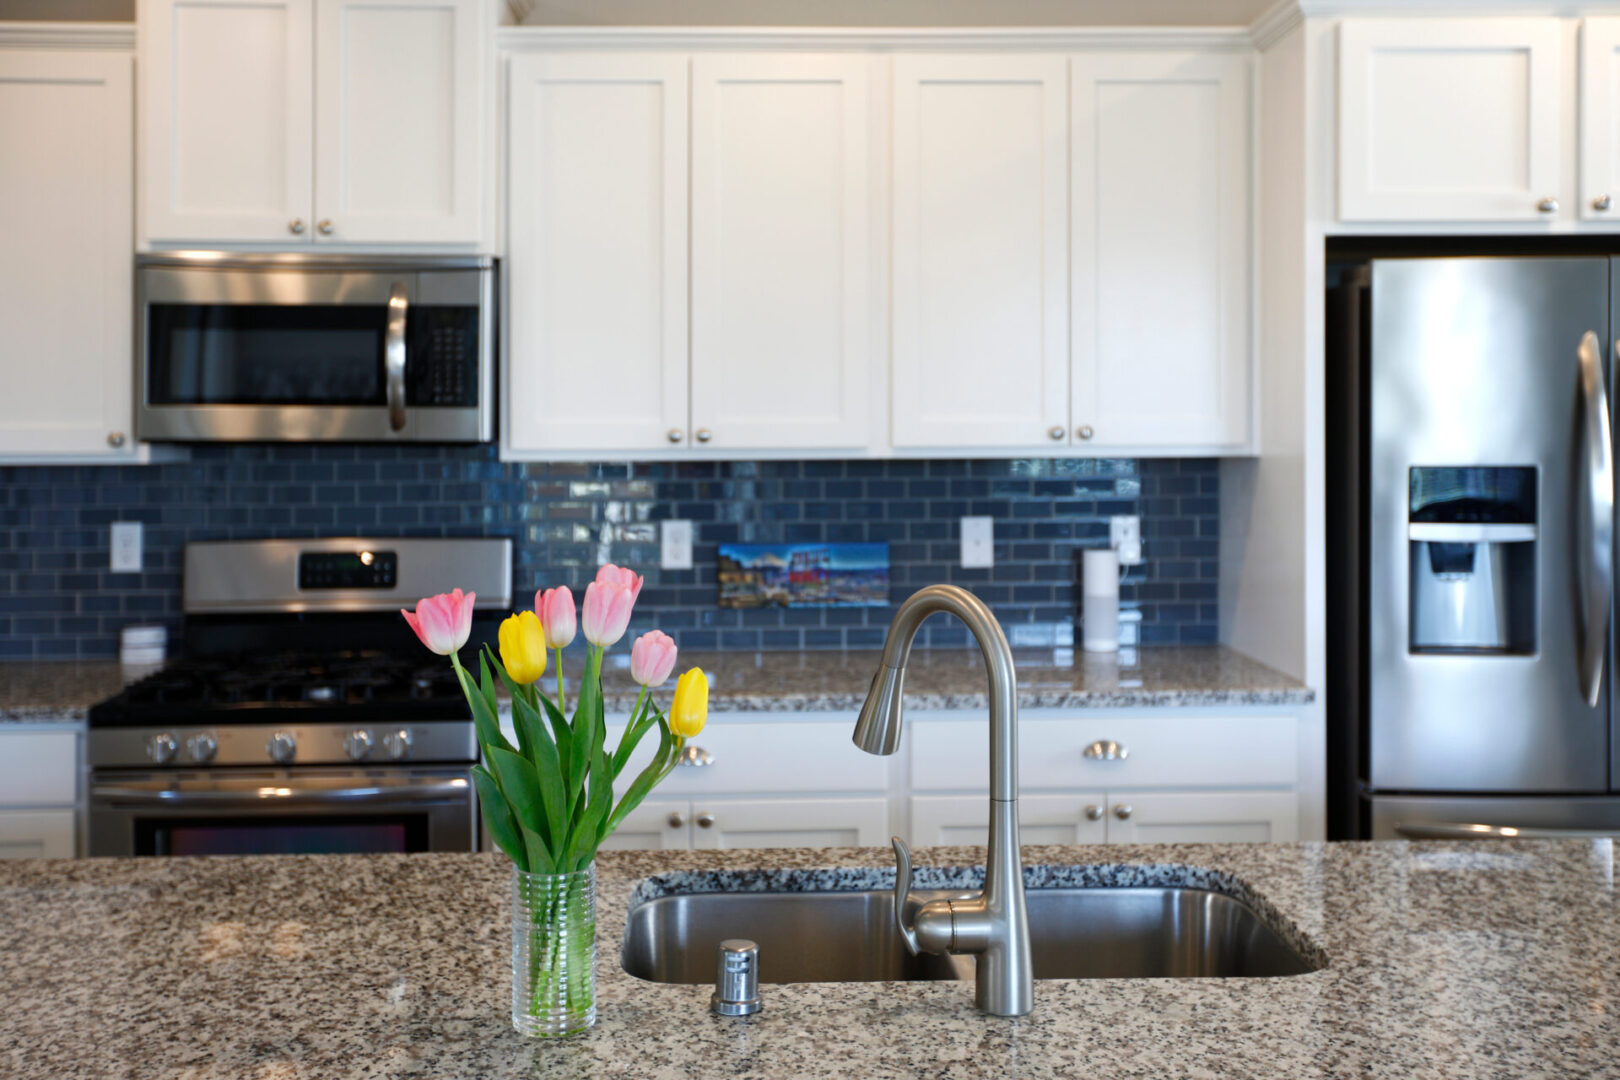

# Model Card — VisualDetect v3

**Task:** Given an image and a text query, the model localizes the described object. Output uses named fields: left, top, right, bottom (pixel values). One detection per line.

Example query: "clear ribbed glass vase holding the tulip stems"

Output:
left=512, top=863, right=596, bottom=1038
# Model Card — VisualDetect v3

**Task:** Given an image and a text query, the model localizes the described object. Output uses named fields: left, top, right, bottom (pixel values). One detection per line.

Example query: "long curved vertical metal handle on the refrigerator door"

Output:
left=1576, top=330, right=1620, bottom=708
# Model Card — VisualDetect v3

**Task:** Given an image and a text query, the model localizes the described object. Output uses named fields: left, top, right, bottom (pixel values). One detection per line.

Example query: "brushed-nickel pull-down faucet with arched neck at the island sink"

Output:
left=855, top=585, right=1035, bottom=1017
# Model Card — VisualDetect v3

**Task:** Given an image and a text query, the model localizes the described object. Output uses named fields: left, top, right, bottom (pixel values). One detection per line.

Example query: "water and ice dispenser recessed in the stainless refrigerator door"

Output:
left=1406, top=466, right=1537, bottom=654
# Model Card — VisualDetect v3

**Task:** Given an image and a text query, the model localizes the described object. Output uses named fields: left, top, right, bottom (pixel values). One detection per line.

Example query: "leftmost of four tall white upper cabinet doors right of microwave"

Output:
left=505, top=53, right=687, bottom=452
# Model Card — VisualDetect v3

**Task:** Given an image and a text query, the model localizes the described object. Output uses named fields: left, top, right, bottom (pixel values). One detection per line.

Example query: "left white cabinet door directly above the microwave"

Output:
left=139, top=0, right=314, bottom=244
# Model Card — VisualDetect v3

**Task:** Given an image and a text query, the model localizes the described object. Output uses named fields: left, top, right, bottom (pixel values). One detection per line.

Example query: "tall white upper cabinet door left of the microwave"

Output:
left=0, top=52, right=134, bottom=459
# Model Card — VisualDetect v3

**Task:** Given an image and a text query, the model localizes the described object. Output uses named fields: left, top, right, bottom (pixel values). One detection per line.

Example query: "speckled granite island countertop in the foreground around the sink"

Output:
left=0, top=840, right=1620, bottom=1080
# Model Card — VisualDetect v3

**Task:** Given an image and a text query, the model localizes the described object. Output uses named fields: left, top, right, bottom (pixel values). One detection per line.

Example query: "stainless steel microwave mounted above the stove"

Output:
left=134, top=251, right=496, bottom=442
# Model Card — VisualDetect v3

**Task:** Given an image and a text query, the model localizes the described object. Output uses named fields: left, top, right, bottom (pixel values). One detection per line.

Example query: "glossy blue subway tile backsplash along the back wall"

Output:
left=0, top=445, right=1220, bottom=659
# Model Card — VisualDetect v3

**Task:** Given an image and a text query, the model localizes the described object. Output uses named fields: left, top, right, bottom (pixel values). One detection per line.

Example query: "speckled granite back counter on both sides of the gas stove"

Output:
left=0, top=644, right=1315, bottom=724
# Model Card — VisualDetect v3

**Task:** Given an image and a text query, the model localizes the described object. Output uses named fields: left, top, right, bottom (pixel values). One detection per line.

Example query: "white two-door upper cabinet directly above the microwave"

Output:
left=139, top=0, right=492, bottom=244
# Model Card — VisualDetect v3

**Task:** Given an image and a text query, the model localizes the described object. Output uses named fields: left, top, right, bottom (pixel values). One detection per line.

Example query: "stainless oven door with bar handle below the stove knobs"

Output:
left=89, top=769, right=476, bottom=855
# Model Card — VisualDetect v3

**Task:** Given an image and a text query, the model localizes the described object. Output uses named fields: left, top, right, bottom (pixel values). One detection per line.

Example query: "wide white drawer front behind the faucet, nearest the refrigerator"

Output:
left=906, top=714, right=1299, bottom=792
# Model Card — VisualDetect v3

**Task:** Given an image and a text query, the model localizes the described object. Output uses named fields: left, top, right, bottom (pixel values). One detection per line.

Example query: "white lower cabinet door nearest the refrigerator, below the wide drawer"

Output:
left=1108, top=792, right=1299, bottom=844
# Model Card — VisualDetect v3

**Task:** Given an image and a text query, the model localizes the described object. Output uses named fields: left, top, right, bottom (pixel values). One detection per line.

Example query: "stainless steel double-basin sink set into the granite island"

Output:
left=620, top=887, right=1319, bottom=983
